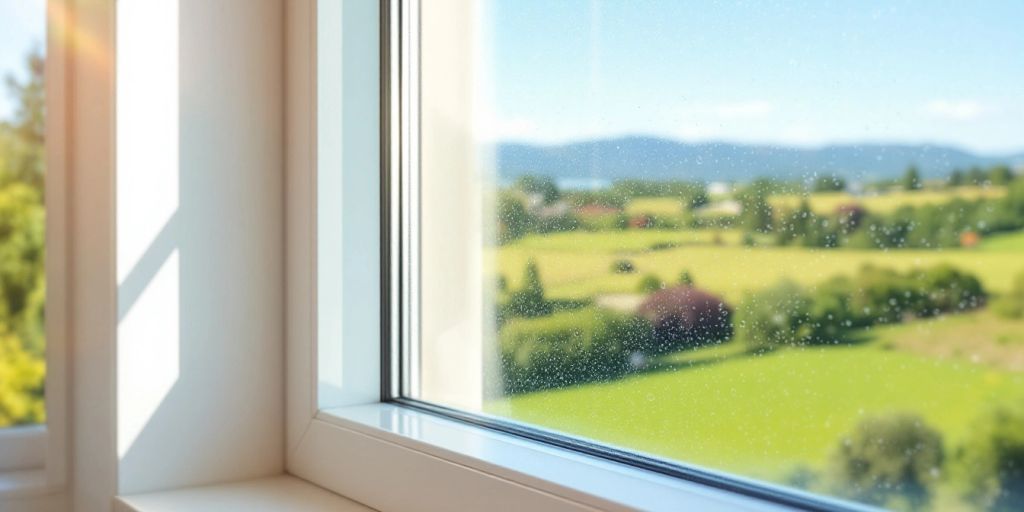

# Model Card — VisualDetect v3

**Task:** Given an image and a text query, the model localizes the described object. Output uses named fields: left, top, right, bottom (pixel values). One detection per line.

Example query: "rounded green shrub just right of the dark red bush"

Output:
left=736, top=281, right=813, bottom=350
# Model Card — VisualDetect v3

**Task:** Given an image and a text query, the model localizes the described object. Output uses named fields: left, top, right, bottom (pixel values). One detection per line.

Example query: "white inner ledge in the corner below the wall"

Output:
left=114, top=475, right=373, bottom=512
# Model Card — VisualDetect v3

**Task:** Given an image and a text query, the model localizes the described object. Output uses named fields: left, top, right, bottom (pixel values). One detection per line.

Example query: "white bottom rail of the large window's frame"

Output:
left=290, top=403, right=790, bottom=511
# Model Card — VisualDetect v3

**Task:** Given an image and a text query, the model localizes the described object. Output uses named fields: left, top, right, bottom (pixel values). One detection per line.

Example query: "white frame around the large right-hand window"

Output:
left=286, top=0, right=858, bottom=510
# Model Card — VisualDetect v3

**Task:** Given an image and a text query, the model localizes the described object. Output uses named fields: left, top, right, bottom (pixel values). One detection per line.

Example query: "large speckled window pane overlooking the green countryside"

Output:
left=403, top=0, right=1024, bottom=510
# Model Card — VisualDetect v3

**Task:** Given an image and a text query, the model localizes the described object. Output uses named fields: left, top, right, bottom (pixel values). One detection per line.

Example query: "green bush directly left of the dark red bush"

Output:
left=499, top=309, right=652, bottom=394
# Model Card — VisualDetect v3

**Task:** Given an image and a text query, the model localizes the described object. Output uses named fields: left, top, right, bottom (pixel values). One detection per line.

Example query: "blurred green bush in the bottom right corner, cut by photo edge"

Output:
left=957, top=406, right=1024, bottom=511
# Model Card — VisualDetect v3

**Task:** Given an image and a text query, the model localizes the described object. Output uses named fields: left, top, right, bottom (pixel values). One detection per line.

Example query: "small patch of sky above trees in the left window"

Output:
left=0, top=0, right=46, bottom=119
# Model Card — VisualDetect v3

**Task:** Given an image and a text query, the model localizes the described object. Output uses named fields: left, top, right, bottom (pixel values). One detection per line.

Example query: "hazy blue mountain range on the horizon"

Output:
left=497, top=136, right=1024, bottom=181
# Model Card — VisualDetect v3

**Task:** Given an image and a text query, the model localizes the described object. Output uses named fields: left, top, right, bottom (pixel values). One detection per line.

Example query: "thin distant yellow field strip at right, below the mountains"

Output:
left=771, top=186, right=1007, bottom=213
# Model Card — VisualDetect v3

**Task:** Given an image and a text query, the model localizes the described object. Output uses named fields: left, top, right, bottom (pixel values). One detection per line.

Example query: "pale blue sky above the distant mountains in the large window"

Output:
left=480, top=0, right=1024, bottom=155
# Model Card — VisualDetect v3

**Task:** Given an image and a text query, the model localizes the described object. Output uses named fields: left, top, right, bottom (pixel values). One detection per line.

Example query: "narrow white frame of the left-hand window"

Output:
left=0, top=0, right=70, bottom=497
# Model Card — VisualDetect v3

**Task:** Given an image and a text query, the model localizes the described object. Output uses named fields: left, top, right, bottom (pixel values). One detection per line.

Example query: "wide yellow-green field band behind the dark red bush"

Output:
left=497, top=230, right=1024, bottom=302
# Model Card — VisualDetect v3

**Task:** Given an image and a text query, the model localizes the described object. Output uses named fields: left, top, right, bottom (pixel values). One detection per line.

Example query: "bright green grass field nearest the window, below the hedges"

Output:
left=488, top=316, right=1024, bottom=481
